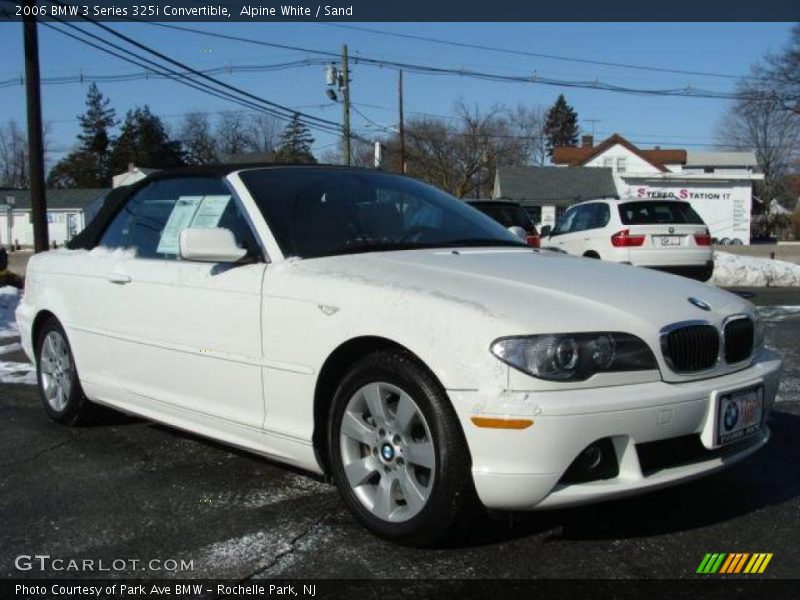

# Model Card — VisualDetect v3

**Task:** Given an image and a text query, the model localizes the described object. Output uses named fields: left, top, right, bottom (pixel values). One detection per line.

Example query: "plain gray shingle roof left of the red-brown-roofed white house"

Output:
left=495, top=167, right=617, bottom=206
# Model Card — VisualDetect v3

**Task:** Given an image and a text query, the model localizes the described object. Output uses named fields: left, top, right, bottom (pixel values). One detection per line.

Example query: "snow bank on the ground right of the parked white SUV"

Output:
left=708, top=252, right=800, bottom=287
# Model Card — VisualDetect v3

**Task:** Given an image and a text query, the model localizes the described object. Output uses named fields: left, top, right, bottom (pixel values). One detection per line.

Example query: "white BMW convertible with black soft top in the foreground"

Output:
left=17, top=166, right=781, bottom=544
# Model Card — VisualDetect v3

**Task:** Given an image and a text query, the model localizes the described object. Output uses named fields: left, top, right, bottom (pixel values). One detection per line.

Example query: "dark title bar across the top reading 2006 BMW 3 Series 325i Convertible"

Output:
left=0, top=0, right=800, bottom=22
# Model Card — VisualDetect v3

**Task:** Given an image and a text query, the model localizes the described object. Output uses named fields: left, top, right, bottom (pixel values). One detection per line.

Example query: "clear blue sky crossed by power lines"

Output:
left=0, top=23, right=791, bottom=166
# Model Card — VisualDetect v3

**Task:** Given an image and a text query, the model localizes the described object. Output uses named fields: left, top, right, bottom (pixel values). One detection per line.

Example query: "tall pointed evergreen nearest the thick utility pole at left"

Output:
left=48, top=83, right=117, bottom=187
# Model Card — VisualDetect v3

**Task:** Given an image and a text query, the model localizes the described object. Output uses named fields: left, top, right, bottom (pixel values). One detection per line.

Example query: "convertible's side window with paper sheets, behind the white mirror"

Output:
left=100, top=177, right=258, bottom=260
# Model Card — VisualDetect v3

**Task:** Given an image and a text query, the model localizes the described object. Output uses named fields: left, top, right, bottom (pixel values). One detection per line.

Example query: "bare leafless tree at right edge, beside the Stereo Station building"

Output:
left=719, top=79, right=800, bottom=206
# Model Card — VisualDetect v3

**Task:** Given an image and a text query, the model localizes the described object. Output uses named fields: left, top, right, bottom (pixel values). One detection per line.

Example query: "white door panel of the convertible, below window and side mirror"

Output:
left=110, top=258, right=265, bottom=427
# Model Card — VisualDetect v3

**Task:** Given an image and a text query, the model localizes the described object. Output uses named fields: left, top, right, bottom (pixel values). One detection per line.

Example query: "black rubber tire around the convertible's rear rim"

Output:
left=36, top=317, right=97, bottom=426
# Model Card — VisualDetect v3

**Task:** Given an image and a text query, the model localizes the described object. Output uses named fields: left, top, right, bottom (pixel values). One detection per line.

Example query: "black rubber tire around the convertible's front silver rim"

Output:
left=327, top=350, right=477, bottom=546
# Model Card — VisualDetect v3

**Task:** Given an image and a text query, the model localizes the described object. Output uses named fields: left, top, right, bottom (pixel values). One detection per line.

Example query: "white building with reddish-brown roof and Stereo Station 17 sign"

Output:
left=553, top=134, right=764, bottom=244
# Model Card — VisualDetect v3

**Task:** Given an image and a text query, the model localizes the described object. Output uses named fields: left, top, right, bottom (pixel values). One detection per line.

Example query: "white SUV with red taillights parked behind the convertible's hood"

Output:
left=542, top=198, right=714, bottom=281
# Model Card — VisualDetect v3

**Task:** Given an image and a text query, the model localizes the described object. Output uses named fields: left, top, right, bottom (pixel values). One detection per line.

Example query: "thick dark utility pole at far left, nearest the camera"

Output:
left=23, top=0, right=49, bottom=252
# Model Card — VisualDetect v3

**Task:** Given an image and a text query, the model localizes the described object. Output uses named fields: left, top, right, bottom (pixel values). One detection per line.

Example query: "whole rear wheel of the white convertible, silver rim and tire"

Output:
left=36, top=319, right=94, bottom=425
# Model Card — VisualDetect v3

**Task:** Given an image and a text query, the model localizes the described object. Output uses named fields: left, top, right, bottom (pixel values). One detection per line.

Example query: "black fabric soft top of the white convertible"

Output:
left=67, top=163, right=363, bottom=250
